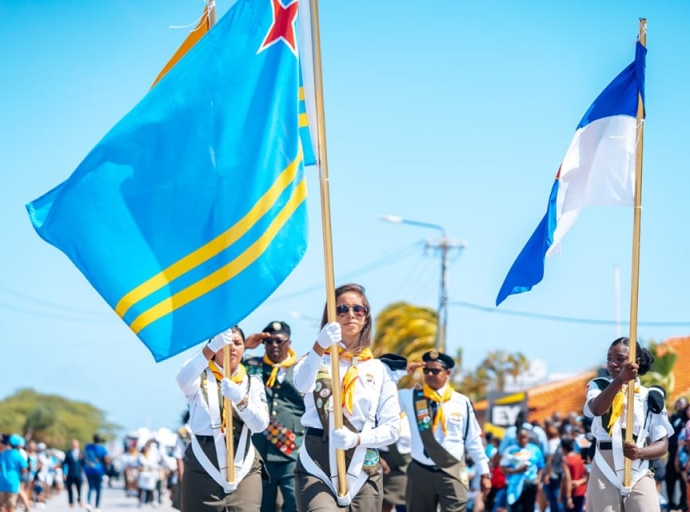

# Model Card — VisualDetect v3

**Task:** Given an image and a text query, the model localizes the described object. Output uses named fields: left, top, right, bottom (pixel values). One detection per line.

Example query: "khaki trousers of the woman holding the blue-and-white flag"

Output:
left=585, top=448, right=661, bottom=512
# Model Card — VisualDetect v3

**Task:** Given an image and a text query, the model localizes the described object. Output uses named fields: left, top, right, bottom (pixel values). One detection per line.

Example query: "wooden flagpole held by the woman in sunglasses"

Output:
left=311, top=0, right=347, bottom=496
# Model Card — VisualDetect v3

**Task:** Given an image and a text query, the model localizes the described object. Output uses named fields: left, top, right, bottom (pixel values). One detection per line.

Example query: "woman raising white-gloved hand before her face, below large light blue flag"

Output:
left=177, top=326, right=268, bottom=512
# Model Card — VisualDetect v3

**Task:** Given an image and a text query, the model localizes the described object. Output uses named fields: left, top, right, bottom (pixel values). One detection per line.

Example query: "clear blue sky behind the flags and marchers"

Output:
left=0, top=0, right=690, bottom=429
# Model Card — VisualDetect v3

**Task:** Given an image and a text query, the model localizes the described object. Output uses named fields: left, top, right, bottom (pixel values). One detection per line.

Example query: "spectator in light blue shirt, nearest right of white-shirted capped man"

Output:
left=501, top=428, right=546, bottom=512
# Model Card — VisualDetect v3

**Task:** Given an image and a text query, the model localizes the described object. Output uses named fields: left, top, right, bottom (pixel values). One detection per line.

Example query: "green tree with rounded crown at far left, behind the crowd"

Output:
left=0, top=388, right=120, bottom=448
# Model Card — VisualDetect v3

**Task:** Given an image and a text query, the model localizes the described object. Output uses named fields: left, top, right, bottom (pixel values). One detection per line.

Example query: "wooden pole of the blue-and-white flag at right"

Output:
left=623, top=18, right=647, bottom=487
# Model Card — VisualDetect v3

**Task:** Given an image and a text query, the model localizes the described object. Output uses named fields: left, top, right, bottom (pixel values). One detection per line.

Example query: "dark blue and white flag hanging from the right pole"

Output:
left=496, top=42, right=647, bottom=306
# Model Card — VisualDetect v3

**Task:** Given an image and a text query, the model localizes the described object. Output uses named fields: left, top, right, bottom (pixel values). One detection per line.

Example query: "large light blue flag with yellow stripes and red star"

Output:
left=27, top=0, right=307, bottom=361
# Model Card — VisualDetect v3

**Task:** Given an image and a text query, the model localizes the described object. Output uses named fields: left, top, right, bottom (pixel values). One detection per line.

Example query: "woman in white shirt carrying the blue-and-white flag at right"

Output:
left=584, top=338, right=673, bottom=512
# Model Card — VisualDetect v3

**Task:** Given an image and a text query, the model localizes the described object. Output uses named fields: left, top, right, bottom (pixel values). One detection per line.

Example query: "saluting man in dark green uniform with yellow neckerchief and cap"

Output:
left=245, top=321, right=304, bottom=512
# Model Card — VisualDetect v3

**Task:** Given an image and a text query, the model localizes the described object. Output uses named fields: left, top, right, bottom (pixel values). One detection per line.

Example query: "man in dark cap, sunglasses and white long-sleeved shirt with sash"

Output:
left=400, top=350, right=491, bottom=512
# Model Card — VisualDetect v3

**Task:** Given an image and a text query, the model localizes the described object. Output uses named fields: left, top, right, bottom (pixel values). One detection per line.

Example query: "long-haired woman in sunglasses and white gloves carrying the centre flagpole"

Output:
left=294, top=284, right=400, bottom=512
